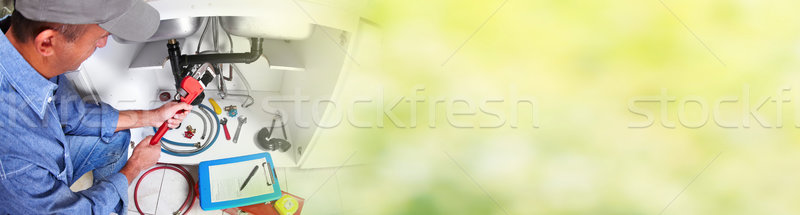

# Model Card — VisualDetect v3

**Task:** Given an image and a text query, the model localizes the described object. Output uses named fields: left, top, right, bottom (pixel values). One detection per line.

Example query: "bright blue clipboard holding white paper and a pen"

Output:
left=198, top=152, right=282, bottom=210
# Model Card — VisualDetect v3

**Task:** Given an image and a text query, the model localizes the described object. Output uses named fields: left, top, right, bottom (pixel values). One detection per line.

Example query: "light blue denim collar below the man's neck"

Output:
left=0, top=23, right=58, bottom=119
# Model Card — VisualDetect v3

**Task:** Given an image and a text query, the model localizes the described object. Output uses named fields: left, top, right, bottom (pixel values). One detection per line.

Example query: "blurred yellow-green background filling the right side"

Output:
left=326, top=0, right=800, bottom=214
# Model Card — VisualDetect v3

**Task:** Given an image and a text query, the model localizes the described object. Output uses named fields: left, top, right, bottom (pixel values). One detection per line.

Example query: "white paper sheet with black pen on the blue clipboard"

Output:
left=208, top=158, right=275, bottom=202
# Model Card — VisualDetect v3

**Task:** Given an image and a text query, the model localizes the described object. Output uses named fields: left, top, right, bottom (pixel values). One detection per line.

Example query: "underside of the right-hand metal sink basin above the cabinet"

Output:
left=220, top=16, right=313, bottom=40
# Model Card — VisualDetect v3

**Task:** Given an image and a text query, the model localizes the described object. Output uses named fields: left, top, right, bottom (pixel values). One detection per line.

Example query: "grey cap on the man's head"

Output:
left=14, top=0, right=161, bottom=41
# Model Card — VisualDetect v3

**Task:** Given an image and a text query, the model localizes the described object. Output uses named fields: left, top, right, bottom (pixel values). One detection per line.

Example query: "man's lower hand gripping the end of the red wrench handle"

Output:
left=119, top=136, right=161, bottom=184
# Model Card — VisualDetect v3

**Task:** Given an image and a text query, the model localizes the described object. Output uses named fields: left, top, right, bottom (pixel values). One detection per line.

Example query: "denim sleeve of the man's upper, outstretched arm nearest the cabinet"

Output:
left=54, top=75, right=119, bottom=142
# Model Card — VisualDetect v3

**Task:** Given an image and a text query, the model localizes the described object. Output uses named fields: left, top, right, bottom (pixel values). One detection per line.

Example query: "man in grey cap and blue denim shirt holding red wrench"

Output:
left=0, top=0, right=191, bottom=214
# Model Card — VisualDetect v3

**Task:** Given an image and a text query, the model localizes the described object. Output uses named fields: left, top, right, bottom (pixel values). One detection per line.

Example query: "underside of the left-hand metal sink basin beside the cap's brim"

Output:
left=115, top=17, right=203, bottom=43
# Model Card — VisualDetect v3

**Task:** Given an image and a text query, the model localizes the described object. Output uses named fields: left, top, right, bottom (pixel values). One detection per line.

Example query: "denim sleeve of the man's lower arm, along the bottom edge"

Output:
left=0, top=166, right=128, bottom=214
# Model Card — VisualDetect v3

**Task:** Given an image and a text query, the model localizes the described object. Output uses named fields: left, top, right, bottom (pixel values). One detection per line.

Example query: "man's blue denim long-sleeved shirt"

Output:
left=0, top=16, right=128, bottom=214
